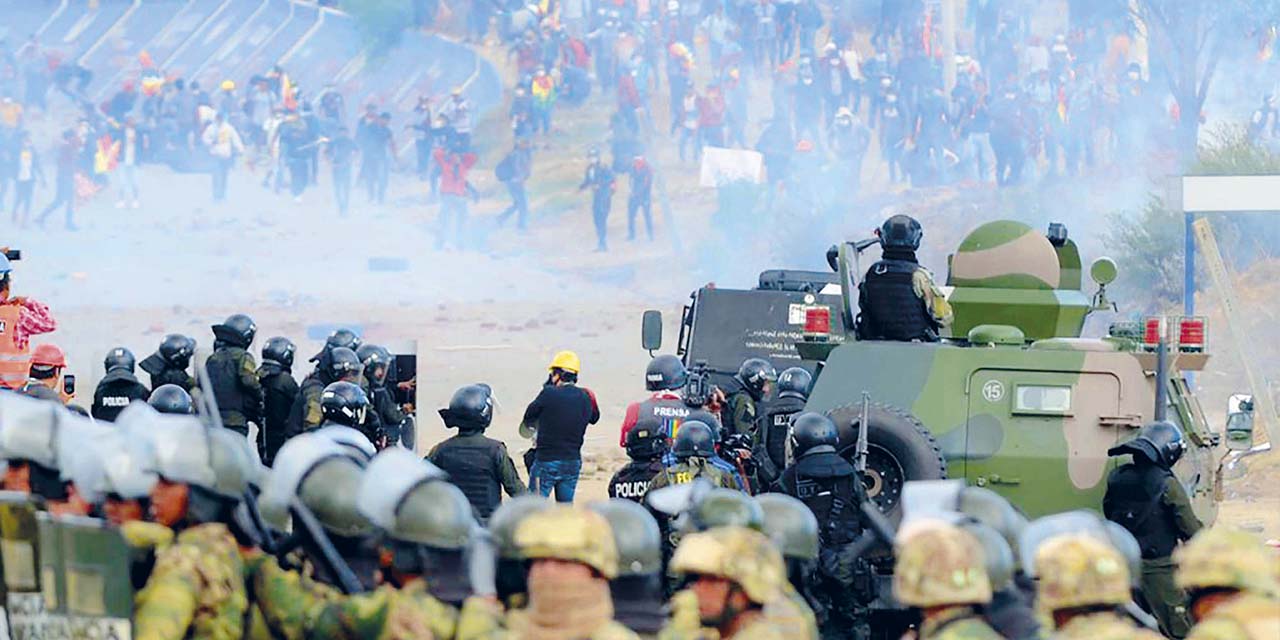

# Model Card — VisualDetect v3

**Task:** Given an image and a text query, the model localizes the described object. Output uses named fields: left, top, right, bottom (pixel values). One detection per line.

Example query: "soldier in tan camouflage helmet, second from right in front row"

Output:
left=1036, top=534, right=1161, bottom=640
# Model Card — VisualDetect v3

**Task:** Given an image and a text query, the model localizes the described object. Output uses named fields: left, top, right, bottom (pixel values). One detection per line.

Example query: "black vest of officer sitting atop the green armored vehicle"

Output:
left=858, top=260, right=938, bottom=342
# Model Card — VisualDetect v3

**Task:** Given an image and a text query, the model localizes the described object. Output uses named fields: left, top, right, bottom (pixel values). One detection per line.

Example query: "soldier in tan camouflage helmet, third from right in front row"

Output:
left=893, top=520, right=1001, bottom=640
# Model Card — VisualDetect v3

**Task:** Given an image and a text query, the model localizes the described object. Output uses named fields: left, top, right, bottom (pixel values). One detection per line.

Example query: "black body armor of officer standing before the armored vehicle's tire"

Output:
left=781, top=452, right=860, bottom=547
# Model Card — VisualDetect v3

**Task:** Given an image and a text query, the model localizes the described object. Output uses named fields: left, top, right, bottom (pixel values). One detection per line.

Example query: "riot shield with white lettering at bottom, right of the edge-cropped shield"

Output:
left=41, top=516, right=133, bottom=640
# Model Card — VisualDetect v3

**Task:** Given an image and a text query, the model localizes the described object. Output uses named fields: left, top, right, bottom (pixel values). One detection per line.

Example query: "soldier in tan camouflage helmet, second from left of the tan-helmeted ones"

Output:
left=663, top=526, right=791, bottom=639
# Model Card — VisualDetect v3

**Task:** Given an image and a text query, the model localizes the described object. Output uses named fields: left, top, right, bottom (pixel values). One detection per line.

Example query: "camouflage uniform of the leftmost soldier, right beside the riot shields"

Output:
left=133, top=524, right=248, bottom=640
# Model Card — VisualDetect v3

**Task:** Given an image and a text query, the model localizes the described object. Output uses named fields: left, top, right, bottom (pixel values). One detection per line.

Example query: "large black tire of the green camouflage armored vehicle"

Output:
left=827, top=402, right=947, bottom=525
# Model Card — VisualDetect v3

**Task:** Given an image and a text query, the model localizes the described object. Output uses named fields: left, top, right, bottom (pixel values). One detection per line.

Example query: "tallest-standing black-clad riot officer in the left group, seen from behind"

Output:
left=205, top=314, right=262, bottom=435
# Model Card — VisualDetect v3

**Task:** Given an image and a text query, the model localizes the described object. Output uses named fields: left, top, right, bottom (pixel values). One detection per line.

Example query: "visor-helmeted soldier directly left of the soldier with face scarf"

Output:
left=308, top=448, right=465, bottom=640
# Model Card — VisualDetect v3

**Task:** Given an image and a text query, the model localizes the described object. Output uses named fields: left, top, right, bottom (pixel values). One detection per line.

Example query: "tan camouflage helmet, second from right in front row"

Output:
left=1036, top=534, right=1130, bottom=612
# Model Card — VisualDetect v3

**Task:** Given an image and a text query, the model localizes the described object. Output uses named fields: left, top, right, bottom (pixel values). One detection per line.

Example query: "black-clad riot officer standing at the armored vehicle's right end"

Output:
left=1102, top=422, right=1203, bottom=637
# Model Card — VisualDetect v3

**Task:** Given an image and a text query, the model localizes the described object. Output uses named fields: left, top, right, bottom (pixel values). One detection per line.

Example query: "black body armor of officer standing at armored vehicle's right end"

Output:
left=1102, top=463, right=1178, bottom=559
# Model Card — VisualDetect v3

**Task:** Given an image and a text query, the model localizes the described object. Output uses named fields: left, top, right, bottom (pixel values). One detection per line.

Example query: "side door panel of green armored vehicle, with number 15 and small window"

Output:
left=964, top=369, right=1126, bottom=518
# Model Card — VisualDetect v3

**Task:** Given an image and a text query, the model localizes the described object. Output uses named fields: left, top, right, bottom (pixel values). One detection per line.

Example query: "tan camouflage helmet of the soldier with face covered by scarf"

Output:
left=516, top=504, right=618, bottom=580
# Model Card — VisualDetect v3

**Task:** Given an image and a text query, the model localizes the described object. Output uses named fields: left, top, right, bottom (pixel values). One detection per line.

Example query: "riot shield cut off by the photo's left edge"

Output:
left=0, top=492, right=45, bottom=640
